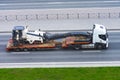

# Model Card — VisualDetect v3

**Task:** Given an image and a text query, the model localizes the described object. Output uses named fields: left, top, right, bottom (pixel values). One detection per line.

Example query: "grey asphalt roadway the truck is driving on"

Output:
left=0, top=32, right=120, bottom=63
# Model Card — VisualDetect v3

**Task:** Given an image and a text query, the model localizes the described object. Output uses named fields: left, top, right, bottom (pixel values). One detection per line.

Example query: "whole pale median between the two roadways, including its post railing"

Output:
left=0, top=8, right=120, bottom=31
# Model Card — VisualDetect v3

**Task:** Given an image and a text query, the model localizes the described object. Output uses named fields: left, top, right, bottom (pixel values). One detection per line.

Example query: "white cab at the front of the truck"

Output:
left=92, top=24, right=108, bottom=49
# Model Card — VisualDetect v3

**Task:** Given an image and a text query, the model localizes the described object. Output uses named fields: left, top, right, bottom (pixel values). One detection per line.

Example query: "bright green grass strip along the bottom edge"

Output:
left=0, top=67, right=120, bottom=80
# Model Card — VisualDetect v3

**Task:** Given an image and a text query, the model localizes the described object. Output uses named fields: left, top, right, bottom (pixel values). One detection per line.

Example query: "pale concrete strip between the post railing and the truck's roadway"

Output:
left=0, top=19, right=120, bottom=31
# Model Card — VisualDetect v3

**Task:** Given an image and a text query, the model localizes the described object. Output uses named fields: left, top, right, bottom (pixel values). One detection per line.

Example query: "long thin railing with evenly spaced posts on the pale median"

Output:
left=0, top=12, right=120, bottom=21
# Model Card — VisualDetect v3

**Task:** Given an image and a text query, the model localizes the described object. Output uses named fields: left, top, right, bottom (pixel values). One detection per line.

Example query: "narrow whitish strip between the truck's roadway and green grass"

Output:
left=0, top=61, right=120, bottom=68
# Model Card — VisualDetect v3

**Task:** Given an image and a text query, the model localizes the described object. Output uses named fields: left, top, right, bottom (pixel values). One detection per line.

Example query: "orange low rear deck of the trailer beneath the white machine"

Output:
left=6, top=39, right=56, bottom=51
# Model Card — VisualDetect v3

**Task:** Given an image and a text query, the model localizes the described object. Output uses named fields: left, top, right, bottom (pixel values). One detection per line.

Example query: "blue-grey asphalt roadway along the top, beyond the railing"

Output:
left=0, top=0, right=120, bottom=10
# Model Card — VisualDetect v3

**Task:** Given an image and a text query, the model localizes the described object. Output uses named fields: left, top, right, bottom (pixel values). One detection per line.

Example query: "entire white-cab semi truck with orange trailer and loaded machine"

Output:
left=6, top=24, right=108, bottom=51
